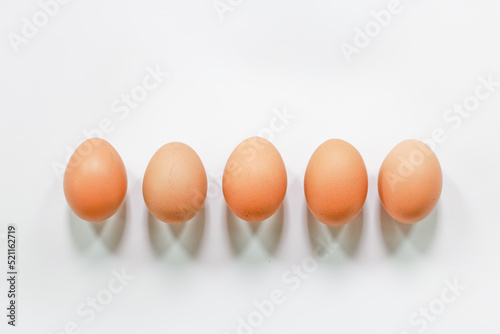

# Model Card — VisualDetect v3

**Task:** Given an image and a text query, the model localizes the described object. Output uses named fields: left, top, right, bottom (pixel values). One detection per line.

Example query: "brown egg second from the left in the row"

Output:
left=142, top=142, right=207, bottom=224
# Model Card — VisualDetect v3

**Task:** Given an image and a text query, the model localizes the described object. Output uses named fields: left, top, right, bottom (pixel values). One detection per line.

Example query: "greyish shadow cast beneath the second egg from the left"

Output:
left=147, top=206, right=206, bottom=258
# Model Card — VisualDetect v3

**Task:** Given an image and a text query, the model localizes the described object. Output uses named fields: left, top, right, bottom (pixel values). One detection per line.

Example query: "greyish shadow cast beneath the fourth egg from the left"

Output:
left=306, top=205, right=364, bottom=262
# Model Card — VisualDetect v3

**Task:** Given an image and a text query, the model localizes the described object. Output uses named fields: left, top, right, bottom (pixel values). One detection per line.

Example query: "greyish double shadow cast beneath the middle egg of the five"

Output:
left=226, top=202, right=285, bottom=260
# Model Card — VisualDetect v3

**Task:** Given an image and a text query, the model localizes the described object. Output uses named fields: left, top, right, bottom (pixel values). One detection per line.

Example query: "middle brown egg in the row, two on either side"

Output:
left=222, top=137, right=287, bottom=222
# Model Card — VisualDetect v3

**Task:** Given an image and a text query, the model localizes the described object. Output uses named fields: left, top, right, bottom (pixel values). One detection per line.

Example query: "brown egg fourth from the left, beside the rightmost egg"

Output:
left=304, top=139, right=368, bottom=226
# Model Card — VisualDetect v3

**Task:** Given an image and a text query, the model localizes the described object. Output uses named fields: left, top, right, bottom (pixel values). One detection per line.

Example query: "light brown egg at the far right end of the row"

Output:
left=378, top=139, right=443, bottom=224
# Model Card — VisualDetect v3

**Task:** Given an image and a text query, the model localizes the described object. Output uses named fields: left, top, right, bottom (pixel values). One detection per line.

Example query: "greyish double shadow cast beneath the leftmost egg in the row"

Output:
left=67, top=199, right=128, bottom=253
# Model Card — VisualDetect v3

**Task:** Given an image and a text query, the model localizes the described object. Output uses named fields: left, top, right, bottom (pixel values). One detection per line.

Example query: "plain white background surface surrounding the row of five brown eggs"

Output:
left=0, top=0, right=500, bottom=334
